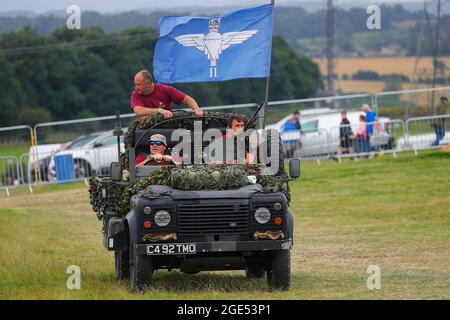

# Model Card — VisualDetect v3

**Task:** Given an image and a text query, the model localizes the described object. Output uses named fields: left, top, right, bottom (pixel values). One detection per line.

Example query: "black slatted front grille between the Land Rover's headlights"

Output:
left=177, top=200, right=250, bottom=236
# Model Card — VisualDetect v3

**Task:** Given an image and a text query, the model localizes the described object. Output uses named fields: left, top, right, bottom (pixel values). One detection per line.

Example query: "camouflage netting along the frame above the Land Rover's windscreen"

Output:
left=120, top=110, right=255, bottom=169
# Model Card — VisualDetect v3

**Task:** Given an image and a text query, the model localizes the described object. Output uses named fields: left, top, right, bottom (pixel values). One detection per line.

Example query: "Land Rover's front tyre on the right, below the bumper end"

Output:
left=267, top=250, right=291, bottom=291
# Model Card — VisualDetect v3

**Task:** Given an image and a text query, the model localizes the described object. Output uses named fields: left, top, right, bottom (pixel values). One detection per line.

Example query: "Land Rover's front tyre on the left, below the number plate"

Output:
left=129, top=243, right=153, bottom=291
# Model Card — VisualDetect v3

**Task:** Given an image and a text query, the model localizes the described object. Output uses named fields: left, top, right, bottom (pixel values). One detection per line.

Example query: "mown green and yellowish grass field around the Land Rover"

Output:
left=0, top=152, right=450, bottom=300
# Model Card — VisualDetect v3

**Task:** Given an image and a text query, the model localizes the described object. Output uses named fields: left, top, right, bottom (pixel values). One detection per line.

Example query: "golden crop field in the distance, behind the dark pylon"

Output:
left=313, top=57, right=450, bottom=79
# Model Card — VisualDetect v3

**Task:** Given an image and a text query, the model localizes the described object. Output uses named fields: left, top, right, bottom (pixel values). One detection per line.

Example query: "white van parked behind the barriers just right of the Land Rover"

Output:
left=266, top=108, right=391, bottom=157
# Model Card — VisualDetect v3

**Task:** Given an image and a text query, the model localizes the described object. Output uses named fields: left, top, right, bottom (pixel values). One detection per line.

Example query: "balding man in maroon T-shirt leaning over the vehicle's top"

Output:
left=131, top=70, right=203, bottom=119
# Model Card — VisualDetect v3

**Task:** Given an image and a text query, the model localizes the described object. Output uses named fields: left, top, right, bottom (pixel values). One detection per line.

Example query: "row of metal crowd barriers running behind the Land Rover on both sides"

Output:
left=0, top=87, right=450, bottom=190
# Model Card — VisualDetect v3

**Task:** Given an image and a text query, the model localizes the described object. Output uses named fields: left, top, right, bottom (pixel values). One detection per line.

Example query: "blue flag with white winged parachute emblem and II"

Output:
left=153, top=5, right=273, bottom=83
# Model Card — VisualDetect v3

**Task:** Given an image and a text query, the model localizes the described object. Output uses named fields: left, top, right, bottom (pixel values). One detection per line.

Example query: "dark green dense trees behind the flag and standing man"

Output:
left=0, top=27, right=322, bottom=126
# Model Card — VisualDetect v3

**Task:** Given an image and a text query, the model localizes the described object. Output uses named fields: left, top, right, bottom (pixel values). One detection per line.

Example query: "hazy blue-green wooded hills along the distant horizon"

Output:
left=0, top=3, right=450, bottom=57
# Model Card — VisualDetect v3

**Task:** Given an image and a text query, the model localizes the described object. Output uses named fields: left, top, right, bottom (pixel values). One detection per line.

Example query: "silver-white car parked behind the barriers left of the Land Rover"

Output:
left=48, top=130, right=125, bottom=180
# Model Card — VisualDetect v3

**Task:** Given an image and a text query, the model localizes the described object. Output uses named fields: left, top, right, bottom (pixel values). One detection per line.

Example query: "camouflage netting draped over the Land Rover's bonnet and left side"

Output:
left=89, top=165, right=290, bottom=218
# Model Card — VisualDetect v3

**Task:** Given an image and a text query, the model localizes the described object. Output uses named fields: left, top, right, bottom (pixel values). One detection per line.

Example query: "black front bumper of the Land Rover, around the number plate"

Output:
left=134, top=239, right=292, bottom=255
